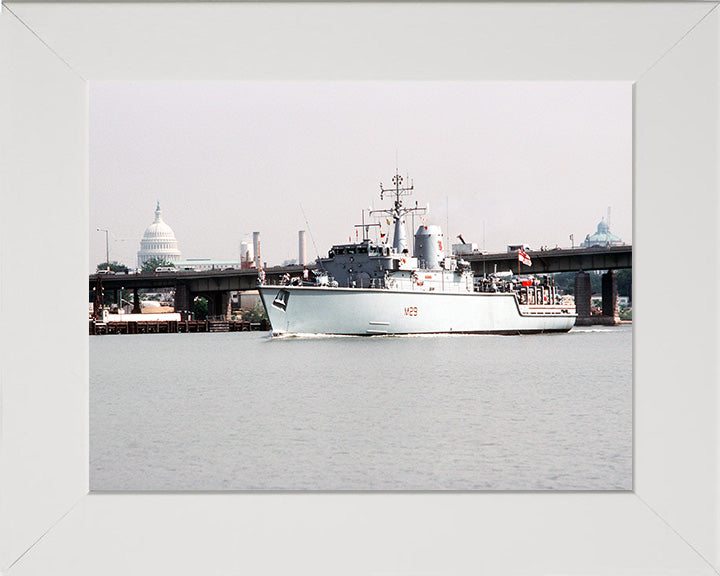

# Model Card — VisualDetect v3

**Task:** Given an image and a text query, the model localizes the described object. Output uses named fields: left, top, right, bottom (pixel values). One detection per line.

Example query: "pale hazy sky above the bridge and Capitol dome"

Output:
left=89, top=82, right=632, bottom=271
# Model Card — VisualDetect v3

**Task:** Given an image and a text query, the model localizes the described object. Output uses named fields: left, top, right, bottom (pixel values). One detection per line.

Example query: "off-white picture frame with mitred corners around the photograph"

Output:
left=0, top=2, right=720, bottom=576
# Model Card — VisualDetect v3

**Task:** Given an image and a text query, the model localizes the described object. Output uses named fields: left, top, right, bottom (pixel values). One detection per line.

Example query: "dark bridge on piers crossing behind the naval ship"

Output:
left=89, top=246, right=632, bottom=325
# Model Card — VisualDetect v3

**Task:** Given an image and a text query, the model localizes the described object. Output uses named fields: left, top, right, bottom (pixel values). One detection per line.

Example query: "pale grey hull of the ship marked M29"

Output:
left=258, top=286, right=577, bottom=336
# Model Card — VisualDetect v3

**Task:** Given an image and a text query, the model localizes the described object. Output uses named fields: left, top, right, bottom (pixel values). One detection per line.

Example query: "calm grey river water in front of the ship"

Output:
left=90, top=325, right=632, bottom=491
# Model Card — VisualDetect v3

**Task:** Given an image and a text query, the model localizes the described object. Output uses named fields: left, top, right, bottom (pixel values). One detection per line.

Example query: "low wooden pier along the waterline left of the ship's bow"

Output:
left=90, top=320, right=270, bottom=336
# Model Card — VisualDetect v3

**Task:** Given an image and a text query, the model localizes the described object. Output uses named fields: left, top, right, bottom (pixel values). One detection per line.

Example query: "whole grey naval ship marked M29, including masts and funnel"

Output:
left=258, top=173, right=577, bottom=336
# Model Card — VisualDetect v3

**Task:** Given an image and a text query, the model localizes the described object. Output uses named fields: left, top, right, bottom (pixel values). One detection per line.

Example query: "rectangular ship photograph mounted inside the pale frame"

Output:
left=87, top=81, right=633, bottom=492
